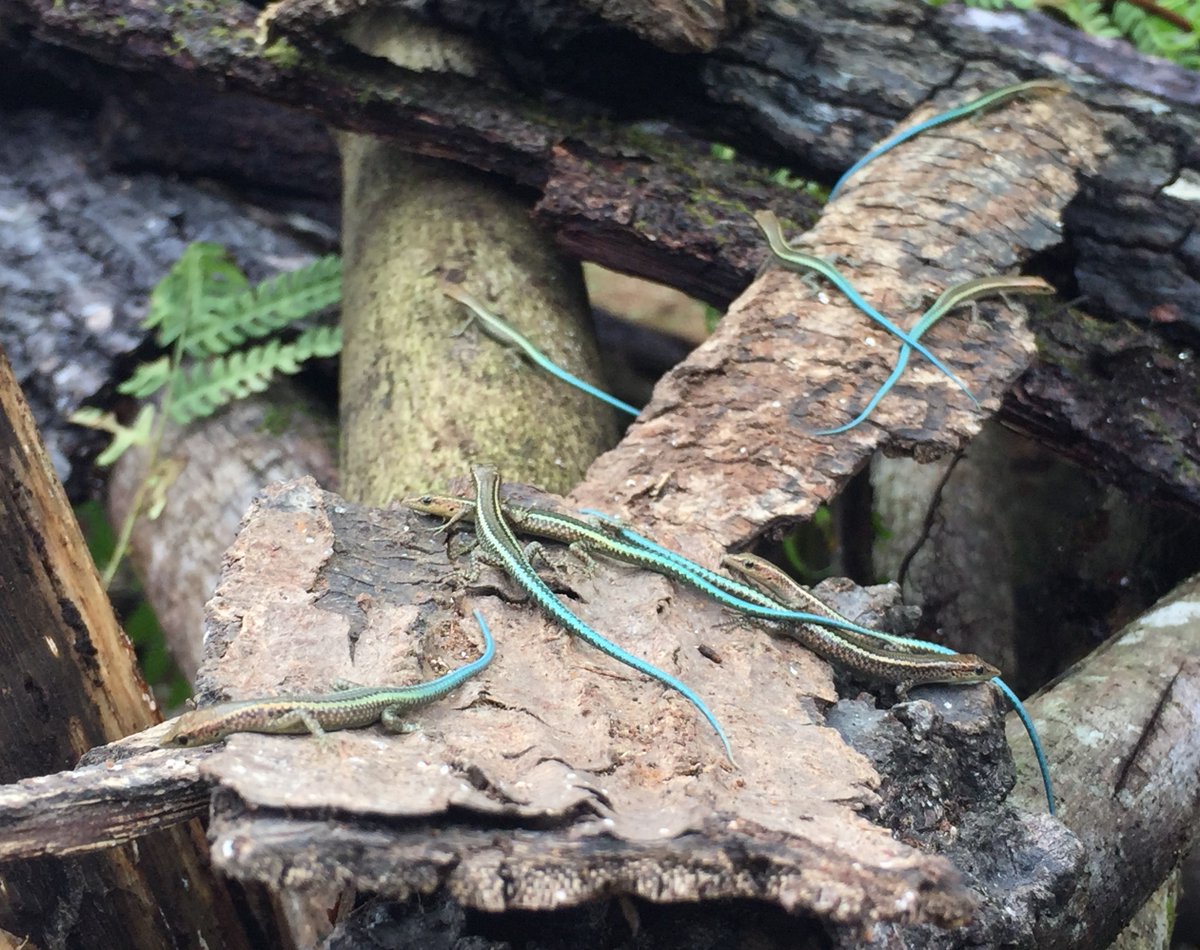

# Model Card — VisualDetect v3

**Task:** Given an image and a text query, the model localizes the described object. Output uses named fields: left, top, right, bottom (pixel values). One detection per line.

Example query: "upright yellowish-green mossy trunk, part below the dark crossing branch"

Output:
left=341, top=136, right=617, bottom=504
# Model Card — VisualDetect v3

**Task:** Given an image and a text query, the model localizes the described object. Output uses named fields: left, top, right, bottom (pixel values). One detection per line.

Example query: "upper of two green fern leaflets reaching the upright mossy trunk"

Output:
left=187, top=255, right=342, bottom=356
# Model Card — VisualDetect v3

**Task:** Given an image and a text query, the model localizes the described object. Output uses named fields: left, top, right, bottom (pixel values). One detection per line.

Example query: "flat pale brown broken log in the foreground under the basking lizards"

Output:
left=154, top=480, right=1056, bottom=927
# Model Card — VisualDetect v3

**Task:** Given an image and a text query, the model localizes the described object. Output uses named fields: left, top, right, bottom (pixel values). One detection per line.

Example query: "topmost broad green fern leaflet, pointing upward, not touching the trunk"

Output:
left=142, top=241, right=246, bottom=347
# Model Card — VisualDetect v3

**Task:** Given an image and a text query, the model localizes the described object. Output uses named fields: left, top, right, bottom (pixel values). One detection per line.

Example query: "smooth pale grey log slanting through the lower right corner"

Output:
left=1009, top=577, right=1200, bottom=948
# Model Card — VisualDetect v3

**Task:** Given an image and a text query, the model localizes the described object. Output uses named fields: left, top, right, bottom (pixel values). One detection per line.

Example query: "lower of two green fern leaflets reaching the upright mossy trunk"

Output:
left=170, top=326, right=342, bottom=426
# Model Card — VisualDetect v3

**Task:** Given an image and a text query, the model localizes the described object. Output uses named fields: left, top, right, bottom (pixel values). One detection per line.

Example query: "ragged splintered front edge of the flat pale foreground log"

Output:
left=210, top=792, right=974, bottom=927
